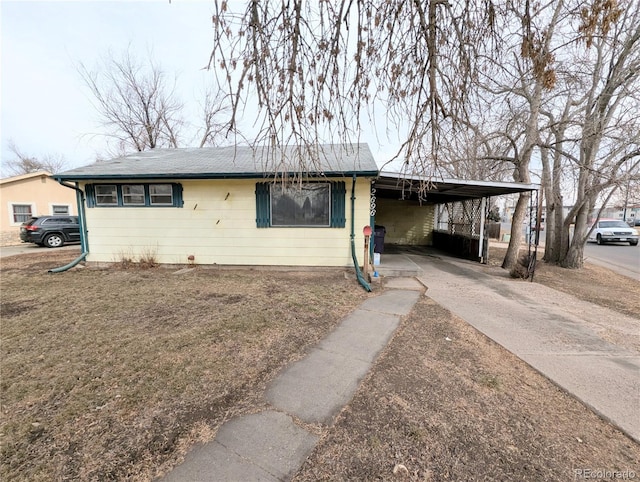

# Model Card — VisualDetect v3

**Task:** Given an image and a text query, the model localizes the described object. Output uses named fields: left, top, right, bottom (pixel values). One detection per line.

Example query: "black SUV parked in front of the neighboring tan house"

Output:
left=20, top=216, right=80, bottom=248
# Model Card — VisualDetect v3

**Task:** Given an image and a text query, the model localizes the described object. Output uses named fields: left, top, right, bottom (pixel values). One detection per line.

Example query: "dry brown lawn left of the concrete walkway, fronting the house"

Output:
left=0, top=251, right=367, bottom=481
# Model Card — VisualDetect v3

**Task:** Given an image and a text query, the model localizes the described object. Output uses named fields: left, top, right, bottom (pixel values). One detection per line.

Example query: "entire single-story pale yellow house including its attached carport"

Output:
left=54, top=144, right=537, bottom=267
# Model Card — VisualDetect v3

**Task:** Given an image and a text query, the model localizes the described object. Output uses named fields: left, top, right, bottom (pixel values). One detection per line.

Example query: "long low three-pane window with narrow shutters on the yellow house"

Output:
left=85, top=184, right=183, bottom=208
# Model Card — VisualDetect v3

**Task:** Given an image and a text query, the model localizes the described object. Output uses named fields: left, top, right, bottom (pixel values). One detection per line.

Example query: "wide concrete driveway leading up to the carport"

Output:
left=404, top=254, right=640, bottom=441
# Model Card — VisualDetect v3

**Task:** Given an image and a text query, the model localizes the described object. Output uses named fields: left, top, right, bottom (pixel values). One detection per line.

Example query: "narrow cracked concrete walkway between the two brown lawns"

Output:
left=162, top=279, right=423, bottom=482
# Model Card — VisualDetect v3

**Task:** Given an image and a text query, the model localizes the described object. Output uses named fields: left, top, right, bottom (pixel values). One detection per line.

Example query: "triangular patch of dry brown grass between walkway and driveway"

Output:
left=294, top=296, right=640, bottom=482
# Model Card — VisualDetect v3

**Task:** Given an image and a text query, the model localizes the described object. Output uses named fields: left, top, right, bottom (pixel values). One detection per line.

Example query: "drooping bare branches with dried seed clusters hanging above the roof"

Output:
left=210, top=0, right=496, bottom=176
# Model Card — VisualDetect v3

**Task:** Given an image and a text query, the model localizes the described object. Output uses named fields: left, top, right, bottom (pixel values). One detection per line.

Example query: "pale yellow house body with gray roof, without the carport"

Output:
left=54, top=144, right=378, bottom=266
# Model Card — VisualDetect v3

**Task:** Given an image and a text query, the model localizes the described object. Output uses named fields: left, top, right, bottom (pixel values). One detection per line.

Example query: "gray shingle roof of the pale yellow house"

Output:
left=53, top=144, right=378, bottom=181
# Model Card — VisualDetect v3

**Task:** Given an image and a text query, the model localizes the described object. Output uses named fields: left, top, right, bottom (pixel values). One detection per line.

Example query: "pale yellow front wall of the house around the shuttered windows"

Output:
left=86, top=178, right=370, bottom=266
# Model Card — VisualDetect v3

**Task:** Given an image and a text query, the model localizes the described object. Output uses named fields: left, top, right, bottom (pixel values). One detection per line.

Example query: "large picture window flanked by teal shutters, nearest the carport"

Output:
left=256, top=182, right=346, bottom=228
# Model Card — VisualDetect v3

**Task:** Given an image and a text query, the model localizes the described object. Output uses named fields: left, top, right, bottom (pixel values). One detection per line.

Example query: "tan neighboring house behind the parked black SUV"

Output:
left=0, top=171, right=76, bottom=245
